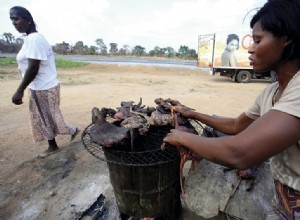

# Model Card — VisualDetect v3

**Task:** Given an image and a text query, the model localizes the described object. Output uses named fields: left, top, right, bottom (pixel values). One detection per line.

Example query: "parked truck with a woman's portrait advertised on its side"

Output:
left=197, top=32, right=276, bottom=83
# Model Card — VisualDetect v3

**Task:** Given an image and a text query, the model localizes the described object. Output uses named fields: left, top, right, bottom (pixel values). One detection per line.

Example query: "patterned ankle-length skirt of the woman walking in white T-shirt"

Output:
left=29, top=84, right=76, bottom=142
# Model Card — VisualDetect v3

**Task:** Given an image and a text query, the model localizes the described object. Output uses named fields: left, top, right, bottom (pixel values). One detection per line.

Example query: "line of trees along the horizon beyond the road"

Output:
left=0, top=33, right=198, bottom=60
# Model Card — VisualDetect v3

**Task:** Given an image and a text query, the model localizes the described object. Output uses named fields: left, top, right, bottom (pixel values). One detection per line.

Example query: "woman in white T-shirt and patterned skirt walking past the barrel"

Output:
left=10, top=6, right=79, bottom=158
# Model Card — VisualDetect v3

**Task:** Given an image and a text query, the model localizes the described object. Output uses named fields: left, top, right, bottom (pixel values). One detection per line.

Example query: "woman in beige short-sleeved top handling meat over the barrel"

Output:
left=164, top=0, right=300, bottom=219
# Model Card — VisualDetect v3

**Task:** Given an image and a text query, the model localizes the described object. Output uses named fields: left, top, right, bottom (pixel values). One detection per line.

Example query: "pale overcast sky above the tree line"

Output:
left=0, top=0, right=267, bottom=51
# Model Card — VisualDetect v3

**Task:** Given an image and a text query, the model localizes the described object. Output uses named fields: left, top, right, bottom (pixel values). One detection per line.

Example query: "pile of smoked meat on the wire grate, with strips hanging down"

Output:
left=89, top=98, right=201, bottom=193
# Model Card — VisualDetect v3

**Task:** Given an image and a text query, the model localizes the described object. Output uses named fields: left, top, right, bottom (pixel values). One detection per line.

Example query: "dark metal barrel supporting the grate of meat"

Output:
left=104, top=127, right=181, bottom=219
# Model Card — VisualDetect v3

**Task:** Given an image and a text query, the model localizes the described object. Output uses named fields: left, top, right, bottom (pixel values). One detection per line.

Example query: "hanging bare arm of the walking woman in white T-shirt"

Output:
left=12, top=59, right=41, bottom=105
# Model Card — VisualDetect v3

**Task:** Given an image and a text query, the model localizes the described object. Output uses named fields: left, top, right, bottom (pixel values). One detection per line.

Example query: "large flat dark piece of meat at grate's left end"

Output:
left=89, top=107, right=129, bottom=147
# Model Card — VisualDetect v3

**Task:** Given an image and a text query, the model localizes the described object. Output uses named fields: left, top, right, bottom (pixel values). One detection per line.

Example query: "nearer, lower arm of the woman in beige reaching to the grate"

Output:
left=164, top=110, right=300, bottom=169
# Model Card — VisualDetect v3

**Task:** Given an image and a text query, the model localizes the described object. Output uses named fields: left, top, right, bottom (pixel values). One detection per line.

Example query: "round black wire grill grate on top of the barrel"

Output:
left=81, top=124, right=180, bottom=166
